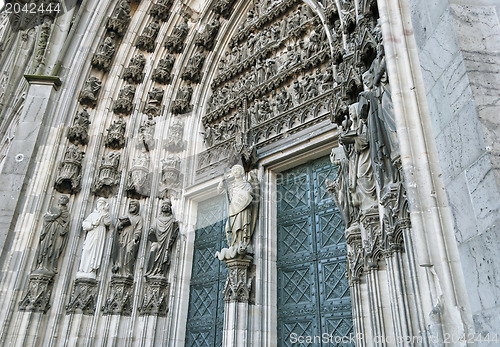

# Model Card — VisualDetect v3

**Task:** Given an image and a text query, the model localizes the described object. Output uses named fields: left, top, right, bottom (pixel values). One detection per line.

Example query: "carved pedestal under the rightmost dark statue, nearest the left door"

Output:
left=139, top=276, right=170, bottom=317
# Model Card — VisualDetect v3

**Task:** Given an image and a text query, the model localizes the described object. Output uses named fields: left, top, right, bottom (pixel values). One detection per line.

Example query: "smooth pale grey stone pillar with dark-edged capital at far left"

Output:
left=0, top=75, right=61, bottom=258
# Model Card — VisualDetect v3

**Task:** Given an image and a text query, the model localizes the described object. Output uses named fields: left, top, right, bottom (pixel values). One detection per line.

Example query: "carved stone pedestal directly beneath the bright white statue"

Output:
left=66, top=278, right=98, bottom=315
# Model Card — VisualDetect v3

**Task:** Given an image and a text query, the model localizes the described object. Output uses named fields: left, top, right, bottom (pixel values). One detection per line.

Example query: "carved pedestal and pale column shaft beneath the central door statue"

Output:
left=222, top=256, right=253, bottom=346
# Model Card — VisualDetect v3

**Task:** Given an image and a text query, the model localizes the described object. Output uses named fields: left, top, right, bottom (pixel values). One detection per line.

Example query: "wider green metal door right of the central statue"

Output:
left=277, top=158, right=353, bottom=346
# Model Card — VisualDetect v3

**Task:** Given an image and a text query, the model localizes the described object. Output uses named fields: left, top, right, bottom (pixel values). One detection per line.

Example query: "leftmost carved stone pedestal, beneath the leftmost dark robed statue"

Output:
left=19, top=271, right=55, bottom=313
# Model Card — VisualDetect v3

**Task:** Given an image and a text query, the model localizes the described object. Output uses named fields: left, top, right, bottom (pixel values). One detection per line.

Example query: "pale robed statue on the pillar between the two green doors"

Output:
left=215, top=165, right=260, bottom=260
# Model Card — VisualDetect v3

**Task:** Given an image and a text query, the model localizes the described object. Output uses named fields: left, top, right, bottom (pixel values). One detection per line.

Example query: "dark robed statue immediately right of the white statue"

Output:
left=112, top=200, right=142, bottom=278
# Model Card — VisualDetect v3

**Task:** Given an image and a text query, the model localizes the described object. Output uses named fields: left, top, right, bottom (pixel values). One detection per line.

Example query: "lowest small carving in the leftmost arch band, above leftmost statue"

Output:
left=55, top=144, right=84, bottom=194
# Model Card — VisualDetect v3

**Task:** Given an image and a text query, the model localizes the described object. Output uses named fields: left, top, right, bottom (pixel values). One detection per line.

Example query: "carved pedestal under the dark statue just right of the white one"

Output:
left=102, top=276, right=134, bottom=316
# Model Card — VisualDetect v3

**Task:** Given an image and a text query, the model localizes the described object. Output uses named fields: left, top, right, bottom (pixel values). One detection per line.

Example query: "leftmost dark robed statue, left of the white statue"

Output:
left=37, top=195, right=69, bottom=273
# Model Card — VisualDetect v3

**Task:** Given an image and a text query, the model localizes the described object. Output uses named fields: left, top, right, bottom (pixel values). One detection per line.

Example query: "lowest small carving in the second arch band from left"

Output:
left=93, top=152, right=120, bottom=197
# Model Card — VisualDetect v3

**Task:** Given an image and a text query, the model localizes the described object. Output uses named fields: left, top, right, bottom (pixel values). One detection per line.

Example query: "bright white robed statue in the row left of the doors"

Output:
left=76, top=198, right=111, bottom=279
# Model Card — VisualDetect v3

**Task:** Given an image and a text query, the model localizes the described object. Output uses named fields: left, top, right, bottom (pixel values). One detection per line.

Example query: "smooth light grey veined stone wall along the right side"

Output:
left=408, top=0, right=500, bottom=335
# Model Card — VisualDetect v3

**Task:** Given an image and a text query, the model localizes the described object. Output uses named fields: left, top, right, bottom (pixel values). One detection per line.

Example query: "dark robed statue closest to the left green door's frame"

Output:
left=146, top=200, right=179, bottom=277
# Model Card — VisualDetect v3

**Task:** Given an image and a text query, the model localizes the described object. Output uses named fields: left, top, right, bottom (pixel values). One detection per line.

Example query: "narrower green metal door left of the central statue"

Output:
left=186, top=196, right=227, bottom=347
